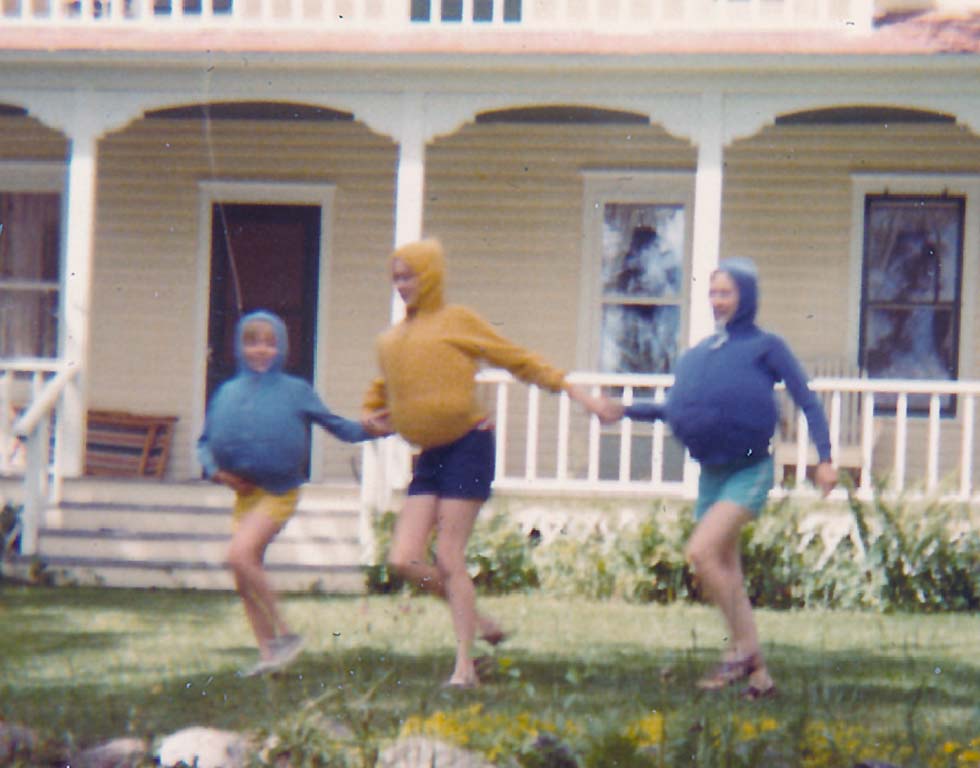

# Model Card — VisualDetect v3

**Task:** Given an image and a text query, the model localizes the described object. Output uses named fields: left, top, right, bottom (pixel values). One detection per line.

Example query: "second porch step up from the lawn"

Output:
left=38, top=529, right=361, bottom=567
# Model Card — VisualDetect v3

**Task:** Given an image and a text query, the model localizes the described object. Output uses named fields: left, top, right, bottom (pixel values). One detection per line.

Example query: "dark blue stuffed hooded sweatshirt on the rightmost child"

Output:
left=625, top=258, right=830, bottom=466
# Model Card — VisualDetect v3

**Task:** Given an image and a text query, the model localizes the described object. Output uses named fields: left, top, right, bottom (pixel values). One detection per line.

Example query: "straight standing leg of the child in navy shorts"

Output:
left=436, top=499, right=483, bottom=685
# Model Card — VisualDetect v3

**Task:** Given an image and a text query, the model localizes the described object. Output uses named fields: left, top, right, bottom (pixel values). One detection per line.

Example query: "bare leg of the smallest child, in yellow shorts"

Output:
left=228, top=511, right=289, bottom=659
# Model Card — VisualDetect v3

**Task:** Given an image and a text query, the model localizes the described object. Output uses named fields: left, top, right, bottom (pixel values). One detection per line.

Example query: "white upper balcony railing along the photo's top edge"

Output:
left=0, top=0, right=874, bottom=35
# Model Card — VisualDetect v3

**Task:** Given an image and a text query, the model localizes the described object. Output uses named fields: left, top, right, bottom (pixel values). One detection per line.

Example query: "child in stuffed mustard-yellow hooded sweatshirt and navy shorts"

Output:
left=364, top=240, right=608, bottom=687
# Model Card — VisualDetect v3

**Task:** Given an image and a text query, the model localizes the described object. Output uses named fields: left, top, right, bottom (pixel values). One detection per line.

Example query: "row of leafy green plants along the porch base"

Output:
left=368, top=493, right=980, bottom=611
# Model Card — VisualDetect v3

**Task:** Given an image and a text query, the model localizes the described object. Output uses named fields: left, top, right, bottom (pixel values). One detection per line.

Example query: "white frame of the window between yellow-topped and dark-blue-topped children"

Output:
left=576, top=169, right=694, bottom=371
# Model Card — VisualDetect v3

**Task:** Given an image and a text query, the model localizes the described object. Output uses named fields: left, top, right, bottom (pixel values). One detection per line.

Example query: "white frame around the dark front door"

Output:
left=189, top=180, right=336, bottom=482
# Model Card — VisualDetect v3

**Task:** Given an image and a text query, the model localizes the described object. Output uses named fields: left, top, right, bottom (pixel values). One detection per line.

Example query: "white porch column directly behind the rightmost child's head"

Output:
left=688, top=91, right=724, bottom=346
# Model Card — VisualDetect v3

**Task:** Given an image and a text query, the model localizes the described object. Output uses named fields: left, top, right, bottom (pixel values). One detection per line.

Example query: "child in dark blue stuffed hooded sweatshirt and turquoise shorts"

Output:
left=611, top=259, right=837, bottom=699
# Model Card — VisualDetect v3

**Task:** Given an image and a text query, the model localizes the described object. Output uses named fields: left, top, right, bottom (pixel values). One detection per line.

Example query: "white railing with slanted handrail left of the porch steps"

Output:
left=0, top=360, right=78, bottom=555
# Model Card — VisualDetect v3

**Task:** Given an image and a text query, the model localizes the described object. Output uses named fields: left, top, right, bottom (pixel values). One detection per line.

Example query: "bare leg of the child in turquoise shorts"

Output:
left=687, top=501, right=771, bottom=688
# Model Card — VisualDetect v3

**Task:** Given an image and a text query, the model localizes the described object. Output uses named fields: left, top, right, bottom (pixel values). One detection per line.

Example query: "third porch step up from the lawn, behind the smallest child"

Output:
left=44, top=502, right=360, bottom=538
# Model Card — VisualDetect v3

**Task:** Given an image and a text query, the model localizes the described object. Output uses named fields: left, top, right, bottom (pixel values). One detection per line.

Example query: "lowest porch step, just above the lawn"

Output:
left=8, top=557, right=365, bottom=595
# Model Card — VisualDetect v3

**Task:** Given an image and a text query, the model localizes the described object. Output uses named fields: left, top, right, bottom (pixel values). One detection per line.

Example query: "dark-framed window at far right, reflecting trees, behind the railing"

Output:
left=859, top=194, right=966, bottom=414
